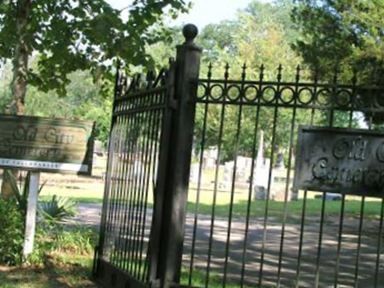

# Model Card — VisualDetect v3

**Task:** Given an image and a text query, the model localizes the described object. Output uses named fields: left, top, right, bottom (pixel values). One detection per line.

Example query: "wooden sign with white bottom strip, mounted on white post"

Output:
left=0, top=115, right=94, bottom=174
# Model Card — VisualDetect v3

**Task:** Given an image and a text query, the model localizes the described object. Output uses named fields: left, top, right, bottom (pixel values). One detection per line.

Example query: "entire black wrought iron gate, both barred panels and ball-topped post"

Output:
left=95, top=26, right=384, bottom=287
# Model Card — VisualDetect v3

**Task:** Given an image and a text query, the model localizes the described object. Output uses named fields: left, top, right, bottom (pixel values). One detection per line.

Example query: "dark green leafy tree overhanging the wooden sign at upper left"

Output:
left=0, top=0, right=187, bottom=115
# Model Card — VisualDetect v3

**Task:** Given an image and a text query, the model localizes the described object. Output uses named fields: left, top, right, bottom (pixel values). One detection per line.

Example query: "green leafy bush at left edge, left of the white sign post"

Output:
left=0, top=198, right=24, bottom=265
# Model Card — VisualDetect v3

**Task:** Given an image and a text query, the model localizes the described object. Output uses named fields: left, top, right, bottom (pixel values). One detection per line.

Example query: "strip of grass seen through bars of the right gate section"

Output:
left=188, top=187, right=382, bottom=219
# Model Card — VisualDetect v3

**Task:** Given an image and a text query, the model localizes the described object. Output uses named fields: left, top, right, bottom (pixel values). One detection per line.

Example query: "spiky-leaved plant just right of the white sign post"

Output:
left=38, top=195, right=76, bottom=224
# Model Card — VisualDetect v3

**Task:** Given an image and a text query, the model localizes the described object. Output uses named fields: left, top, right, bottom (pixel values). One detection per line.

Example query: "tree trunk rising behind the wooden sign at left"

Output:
left=1, top=0, right=32, bottom=199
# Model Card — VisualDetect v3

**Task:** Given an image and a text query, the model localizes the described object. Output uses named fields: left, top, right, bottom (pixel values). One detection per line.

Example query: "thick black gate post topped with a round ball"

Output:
left=157, top=24, right=201, bottom=288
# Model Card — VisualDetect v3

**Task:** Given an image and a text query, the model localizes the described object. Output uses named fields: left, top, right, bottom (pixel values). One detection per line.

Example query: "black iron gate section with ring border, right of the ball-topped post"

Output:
left=183, top=66, right=384, bottom=287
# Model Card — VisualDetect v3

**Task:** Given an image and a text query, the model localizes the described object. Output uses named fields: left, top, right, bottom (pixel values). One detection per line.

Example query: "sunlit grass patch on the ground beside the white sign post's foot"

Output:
left=0, top=226, right=97, bottom=288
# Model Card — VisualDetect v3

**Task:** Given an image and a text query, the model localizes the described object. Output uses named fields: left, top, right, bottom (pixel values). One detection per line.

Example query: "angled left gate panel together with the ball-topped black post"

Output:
left=94, top=25, right=200, bottom=287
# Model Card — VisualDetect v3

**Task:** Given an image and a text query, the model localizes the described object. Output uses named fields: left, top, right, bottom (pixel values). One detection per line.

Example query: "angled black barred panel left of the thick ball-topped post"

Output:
left=94, top=70, right=168, bottom=287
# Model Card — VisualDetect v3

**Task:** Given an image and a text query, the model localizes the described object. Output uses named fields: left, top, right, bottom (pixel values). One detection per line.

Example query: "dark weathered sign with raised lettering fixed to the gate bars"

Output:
left=294, top=126, right=384, bottom=197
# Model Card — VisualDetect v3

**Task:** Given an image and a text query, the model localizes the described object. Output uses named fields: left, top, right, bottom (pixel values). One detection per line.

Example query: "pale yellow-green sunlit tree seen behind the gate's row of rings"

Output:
left=191, top=0, right=307, bottom=161
